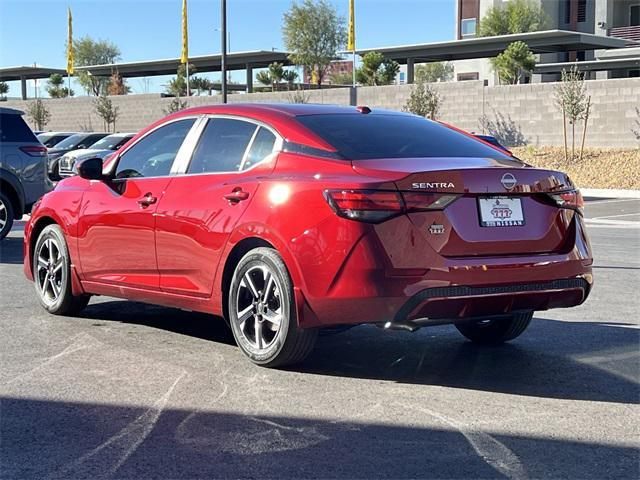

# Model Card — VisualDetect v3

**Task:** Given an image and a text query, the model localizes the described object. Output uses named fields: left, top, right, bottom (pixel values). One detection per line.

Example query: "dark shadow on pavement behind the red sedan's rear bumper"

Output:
left=302, top=318, right=640, bottom=403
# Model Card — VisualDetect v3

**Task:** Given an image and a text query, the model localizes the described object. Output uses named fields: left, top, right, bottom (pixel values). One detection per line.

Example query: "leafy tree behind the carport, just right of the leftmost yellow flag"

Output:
left=73, top=36, right=120, bottom=96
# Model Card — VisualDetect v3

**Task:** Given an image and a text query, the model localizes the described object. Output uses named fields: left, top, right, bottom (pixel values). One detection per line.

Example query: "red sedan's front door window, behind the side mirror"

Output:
left=116, top=118, right=196, bottom=178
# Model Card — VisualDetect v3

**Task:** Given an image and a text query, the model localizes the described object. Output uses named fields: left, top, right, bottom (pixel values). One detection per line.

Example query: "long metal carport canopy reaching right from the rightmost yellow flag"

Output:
left=350, top=30, right=636, bottom=64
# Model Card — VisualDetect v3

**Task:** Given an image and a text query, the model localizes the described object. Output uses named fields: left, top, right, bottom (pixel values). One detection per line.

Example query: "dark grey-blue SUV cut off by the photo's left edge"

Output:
left=0, top=107, right=51, bottom=239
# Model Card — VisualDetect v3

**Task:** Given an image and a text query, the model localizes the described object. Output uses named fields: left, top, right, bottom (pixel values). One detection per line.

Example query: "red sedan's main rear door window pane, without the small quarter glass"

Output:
left=187, top=118, right=257, bottom=173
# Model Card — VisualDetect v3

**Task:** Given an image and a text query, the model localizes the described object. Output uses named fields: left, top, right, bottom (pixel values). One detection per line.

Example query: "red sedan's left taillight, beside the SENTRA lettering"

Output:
left=325, top=190, right=457, bottom=223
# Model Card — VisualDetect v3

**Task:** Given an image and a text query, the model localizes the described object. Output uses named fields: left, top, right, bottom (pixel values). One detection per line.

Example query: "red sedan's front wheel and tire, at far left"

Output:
left=33, top=224, right=90, bottom=315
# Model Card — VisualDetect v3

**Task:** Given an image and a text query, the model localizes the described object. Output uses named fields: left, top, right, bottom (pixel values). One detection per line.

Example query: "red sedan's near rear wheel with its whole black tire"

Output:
left=228, top=247, right=318, bottom=368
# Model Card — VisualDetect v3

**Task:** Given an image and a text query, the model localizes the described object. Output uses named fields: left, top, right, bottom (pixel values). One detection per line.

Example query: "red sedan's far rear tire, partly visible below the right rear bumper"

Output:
left=456, top=312, right=533, bottom=345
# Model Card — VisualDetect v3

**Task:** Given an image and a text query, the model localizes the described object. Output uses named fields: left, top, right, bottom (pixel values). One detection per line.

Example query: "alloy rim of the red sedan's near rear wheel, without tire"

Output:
left=236, top=265, right=283, bottom=350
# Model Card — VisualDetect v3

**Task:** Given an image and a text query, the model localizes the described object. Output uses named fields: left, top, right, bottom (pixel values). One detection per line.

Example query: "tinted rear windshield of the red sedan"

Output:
left=296, top=113, right=511, bottom=160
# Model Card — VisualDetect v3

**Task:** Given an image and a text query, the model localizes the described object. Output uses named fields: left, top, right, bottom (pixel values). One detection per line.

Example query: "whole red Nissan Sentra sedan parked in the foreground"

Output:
left=24, top=105, right=592, bottom=366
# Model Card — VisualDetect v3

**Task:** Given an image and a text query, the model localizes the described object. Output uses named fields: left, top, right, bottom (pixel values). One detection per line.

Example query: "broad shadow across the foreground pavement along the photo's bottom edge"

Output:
left=0, top=396, right=637, bottom=479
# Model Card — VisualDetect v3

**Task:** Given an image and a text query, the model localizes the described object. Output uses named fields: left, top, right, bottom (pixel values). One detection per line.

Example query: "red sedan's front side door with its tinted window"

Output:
left=78, top=118, right=196, bottom=290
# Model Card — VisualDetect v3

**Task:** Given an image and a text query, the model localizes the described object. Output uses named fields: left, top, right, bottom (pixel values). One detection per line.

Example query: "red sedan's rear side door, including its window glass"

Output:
left=156, top=117, right=282, bottom=297
